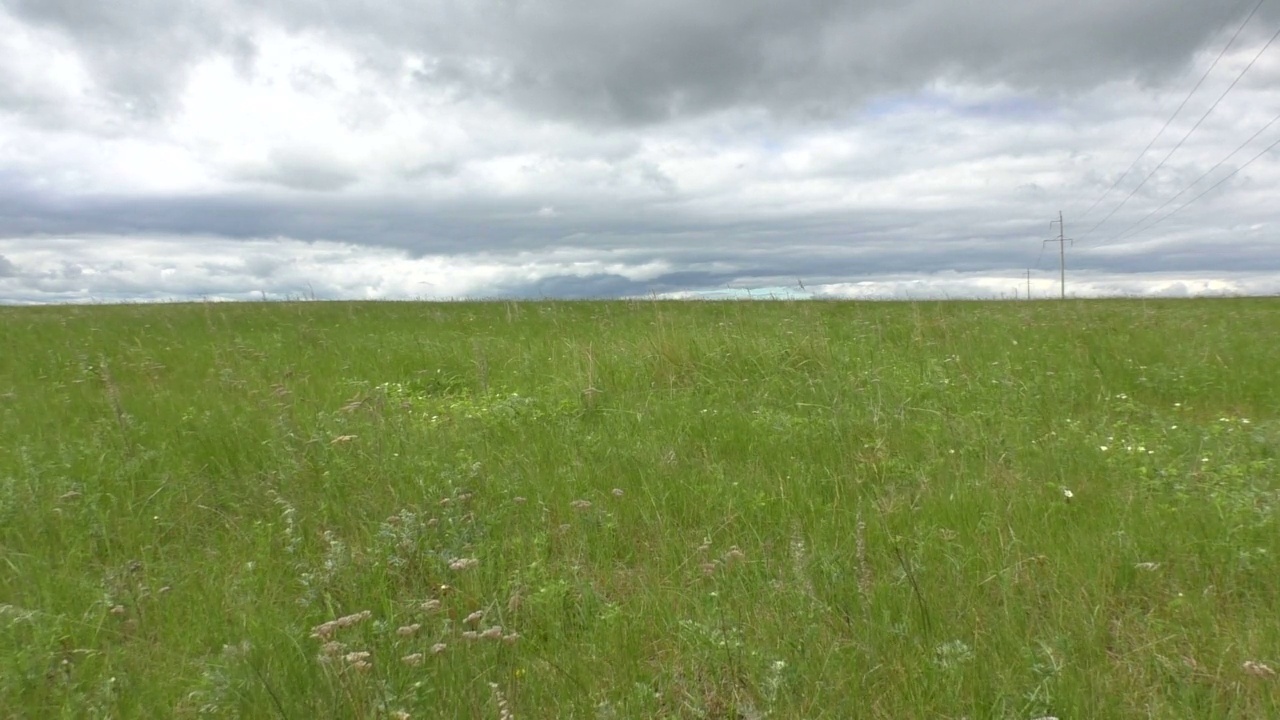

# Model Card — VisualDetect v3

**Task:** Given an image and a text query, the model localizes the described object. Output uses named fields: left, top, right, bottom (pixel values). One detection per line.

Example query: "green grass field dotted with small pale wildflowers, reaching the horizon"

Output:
left=0, top=300, right=1280, bottom=720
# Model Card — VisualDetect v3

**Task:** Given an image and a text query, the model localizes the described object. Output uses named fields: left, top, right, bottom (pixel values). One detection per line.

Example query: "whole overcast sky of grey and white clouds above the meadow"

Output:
left=0, top=0, right=1280, bottom=304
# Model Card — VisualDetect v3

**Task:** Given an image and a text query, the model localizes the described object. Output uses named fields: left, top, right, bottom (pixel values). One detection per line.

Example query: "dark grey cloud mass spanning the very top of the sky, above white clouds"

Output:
left=9, top=0, right=1280, bottom=124
